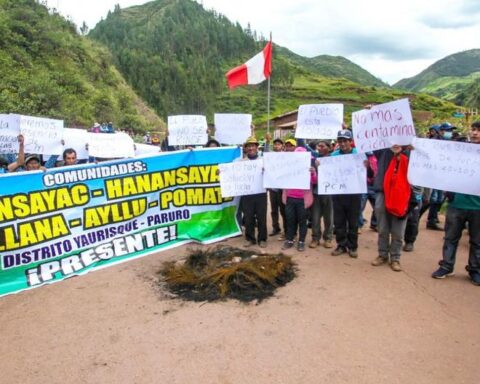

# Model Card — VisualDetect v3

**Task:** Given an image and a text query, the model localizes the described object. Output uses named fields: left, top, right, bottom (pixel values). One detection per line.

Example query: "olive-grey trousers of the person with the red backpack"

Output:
left=375, top=192, right=407, bottom=261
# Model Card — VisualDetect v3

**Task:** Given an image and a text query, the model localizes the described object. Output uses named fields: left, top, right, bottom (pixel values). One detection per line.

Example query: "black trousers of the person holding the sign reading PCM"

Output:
left=332, top=194, right=362, bottom=251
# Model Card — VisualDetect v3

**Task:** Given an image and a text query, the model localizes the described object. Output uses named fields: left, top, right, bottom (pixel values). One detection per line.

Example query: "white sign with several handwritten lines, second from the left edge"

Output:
left=10, top=114, right=63, bottom=155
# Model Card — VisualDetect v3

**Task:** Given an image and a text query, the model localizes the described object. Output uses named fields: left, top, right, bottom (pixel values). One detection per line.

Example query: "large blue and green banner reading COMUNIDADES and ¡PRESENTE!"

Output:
left=0, top=148, right=241, bottom=296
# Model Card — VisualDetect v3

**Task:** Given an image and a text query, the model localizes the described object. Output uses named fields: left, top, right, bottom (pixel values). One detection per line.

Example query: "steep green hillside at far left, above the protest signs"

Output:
left=0, top=0, right=165, bottom=131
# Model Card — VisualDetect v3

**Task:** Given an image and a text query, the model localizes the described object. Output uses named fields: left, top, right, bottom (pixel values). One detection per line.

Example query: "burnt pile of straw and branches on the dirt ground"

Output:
left=159, top=246, right=296, bottom=302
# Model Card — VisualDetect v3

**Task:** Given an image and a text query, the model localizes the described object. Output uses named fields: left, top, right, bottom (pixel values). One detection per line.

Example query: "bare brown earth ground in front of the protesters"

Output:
left=0, top=210, right=480, bottom=384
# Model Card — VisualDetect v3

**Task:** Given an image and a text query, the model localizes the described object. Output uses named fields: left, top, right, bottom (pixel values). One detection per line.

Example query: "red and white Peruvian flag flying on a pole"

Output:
left=225, top=41, right=272, bottom=89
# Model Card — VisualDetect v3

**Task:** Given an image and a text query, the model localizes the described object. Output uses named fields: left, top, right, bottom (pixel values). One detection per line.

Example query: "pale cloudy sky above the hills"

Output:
left=48, top=0, right=480, bottom=84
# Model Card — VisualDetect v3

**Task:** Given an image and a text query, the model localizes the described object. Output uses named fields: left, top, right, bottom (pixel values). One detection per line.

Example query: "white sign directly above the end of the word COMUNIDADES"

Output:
left=87, top=132, right=135, bottom=159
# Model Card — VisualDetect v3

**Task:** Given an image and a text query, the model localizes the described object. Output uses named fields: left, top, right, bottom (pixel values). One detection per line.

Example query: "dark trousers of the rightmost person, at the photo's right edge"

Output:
left=439, top=206, right=480, bottom=273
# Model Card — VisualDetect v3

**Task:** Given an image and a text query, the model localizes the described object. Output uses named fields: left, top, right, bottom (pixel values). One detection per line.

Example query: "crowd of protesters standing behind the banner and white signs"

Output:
left=2, top=121, right=480, bottom=285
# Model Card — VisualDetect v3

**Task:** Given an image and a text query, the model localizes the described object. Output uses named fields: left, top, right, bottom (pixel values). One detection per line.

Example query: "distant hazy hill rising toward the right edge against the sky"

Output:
left=394, top=49, right=480, bottom=108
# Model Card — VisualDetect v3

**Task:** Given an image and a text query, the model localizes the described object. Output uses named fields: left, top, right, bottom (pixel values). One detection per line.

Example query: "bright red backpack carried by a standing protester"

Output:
left=383, top=153, right=411, bottom=219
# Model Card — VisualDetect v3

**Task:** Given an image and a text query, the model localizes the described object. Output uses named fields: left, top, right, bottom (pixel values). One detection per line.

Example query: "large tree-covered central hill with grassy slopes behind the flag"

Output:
left=89, top=0, right=456, bottom=132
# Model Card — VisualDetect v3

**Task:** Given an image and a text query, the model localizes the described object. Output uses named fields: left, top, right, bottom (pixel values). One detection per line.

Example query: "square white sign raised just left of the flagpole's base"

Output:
left=214, top=113, right=252, bottom=145
